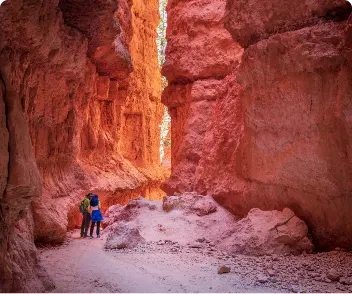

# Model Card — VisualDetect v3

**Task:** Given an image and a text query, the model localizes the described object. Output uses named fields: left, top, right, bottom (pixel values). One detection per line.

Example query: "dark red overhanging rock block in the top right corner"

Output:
left=225, top=0, right=350, bottom=47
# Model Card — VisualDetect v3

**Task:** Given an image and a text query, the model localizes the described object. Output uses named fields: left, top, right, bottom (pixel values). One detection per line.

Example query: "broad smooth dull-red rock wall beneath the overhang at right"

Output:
left=223, top=1, right=352, bottom=249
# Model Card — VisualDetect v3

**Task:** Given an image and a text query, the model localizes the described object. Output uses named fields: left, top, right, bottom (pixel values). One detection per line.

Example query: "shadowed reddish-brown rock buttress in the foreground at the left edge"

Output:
left=0, top=56, right=49, bottom=293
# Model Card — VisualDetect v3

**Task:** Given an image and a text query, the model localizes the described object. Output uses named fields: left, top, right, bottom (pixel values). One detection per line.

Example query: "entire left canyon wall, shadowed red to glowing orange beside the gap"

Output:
left=0, top=0, right=164, bottom=293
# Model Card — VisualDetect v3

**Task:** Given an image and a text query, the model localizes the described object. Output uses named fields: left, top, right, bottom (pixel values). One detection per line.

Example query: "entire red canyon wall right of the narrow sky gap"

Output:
left=163, top=0, right=352, bottom=249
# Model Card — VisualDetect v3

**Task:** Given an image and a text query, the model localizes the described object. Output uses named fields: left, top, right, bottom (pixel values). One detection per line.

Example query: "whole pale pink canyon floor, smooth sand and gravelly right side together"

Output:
left=40, top=232, right=352, bottom=294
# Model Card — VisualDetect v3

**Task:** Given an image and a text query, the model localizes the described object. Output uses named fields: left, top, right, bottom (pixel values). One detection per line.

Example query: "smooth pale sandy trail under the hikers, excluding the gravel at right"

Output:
left=40, top=233, right=280, bottom=294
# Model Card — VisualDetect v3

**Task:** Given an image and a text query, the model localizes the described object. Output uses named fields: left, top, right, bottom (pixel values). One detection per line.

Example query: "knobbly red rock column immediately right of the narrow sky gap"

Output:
left=162, top=0, right=242, bottom=195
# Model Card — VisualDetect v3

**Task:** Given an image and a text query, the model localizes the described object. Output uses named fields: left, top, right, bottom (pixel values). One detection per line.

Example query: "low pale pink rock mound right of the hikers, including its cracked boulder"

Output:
left=104, top=192, right=314, bottom=255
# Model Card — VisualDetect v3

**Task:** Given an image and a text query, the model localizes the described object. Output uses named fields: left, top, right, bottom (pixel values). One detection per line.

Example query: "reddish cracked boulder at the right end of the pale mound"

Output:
left=220, top=208, right=314, bottom=255
